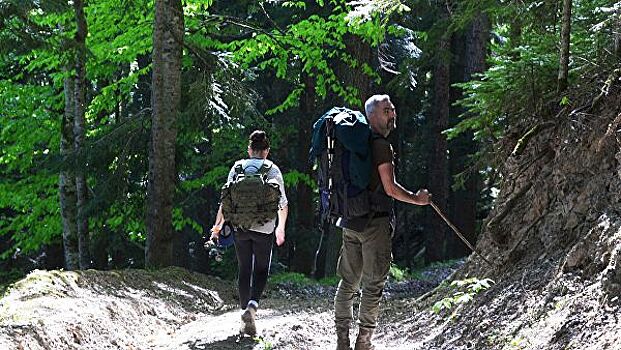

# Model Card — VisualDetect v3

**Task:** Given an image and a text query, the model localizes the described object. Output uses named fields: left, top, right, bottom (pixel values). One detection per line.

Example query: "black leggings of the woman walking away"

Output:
left=235, top=229, right=274, bottom=309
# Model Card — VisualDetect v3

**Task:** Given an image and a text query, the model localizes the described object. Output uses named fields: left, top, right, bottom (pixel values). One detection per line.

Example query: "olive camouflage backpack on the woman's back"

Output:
left=220, top=160, right=280, bottom=230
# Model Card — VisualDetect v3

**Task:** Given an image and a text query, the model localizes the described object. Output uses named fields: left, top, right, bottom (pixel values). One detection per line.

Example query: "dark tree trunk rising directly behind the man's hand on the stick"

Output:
left=425, top=35, right=451, bottom=262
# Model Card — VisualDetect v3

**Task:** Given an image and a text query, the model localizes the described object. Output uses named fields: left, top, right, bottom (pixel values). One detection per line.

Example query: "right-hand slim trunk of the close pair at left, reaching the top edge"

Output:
left=73, top=0, right=91, bottom=269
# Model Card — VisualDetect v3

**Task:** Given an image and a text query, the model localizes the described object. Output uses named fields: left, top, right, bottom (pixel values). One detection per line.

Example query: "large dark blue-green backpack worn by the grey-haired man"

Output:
left=310, top=107, right=392, bottom=223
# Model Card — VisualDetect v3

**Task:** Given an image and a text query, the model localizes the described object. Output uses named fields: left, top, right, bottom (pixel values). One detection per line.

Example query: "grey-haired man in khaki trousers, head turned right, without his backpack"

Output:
left=334, top=95, right=431, bottom=350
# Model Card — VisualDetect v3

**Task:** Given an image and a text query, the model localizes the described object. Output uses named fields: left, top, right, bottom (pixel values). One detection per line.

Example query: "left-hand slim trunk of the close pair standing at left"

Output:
left=59, top=69, right=79, bottom=270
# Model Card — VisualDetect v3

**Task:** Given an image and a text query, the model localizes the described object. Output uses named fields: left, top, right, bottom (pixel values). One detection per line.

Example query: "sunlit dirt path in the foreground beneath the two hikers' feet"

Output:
left=147, top=299, right=432, bottom=350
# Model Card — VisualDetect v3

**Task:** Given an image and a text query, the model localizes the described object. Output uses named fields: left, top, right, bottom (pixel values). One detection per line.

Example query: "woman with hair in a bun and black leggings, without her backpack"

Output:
left=211, top=130, right=288, bottom=335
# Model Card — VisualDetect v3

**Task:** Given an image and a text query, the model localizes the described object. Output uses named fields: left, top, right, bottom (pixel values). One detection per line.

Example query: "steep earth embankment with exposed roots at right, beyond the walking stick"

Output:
left=382, top=77, right=621, bottom=350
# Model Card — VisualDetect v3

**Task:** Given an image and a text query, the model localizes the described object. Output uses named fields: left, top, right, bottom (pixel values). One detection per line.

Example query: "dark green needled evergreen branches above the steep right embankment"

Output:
left=445, top=0, right=612, bottom=173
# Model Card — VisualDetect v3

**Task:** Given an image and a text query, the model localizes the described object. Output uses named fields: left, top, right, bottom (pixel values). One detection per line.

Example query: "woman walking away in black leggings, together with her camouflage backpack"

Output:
left=210, top=130, right=288, bottom=335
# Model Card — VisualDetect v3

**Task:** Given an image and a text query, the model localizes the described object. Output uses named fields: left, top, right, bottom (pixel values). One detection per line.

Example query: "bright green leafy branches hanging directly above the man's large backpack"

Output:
left=226, top=1, right=385, bottom=110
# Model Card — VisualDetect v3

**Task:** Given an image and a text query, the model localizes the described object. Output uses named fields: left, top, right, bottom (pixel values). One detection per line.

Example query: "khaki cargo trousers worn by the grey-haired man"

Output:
left=334, top=217, right=392, bottom=328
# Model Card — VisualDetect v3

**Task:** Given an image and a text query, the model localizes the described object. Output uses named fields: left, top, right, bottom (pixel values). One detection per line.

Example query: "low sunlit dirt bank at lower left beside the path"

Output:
left=0, top=269, right=234, bottom=349
